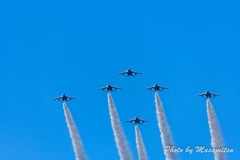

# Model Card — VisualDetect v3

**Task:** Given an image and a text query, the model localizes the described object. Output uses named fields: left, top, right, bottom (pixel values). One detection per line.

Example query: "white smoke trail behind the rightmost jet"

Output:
left=207, top=99, right=226, bottom=160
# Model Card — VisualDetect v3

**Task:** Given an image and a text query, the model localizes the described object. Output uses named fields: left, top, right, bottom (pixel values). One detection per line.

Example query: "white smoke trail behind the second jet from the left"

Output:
left=108, top=93, right=133, bottom=160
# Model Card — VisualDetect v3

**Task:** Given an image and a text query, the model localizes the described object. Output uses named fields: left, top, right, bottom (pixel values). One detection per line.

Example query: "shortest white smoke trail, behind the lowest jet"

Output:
left=135, top=125, right=148, bottom=160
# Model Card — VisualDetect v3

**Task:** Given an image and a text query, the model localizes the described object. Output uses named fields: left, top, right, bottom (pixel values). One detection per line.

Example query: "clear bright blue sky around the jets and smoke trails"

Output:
left=0, top=0, right=240, bottom=160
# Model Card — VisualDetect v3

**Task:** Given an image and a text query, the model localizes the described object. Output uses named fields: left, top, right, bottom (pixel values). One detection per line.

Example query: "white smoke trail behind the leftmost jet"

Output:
left=63, top=102, right=87, bottom=160
